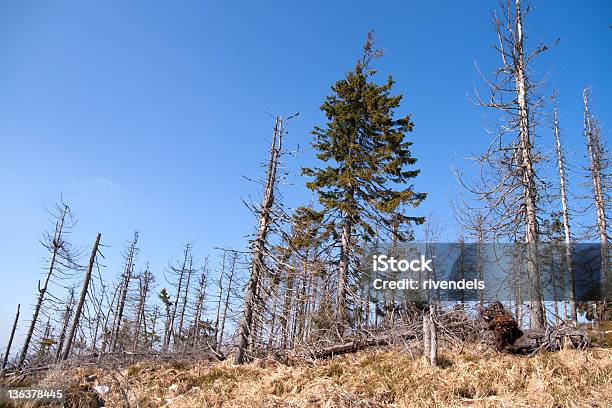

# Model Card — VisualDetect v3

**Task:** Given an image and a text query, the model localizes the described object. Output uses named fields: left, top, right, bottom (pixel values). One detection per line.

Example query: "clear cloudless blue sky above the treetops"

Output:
left=0, top=0, right=612, bottom=348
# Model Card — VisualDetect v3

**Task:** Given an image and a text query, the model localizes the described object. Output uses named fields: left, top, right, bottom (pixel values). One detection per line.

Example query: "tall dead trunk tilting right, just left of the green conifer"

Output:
left=234, top=116, right=284, bottom=364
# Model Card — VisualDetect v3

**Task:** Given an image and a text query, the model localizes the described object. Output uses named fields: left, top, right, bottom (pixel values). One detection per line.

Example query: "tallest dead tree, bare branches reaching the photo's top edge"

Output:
left=464, top=0, right=548, bottom=328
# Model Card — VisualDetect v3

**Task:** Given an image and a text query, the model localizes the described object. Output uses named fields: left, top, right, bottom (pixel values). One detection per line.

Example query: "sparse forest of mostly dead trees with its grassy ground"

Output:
left=0, top=0, right=612, bottom=407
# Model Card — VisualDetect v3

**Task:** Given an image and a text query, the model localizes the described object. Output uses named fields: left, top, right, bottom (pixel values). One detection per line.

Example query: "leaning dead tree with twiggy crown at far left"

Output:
left=17, top=204, right=76, bottom=368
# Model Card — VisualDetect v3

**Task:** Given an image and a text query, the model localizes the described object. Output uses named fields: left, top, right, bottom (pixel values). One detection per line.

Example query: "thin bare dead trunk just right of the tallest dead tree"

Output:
left=552, top=95, right=578, bottom=323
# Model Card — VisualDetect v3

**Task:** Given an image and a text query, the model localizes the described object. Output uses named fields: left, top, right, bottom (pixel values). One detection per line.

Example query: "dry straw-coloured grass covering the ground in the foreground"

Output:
left=13, top=349, right=612, bottom=408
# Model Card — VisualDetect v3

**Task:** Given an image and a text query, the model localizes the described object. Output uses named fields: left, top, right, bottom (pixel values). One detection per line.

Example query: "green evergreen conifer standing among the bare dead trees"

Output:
left=302, top=32, right=426, bottom=330
